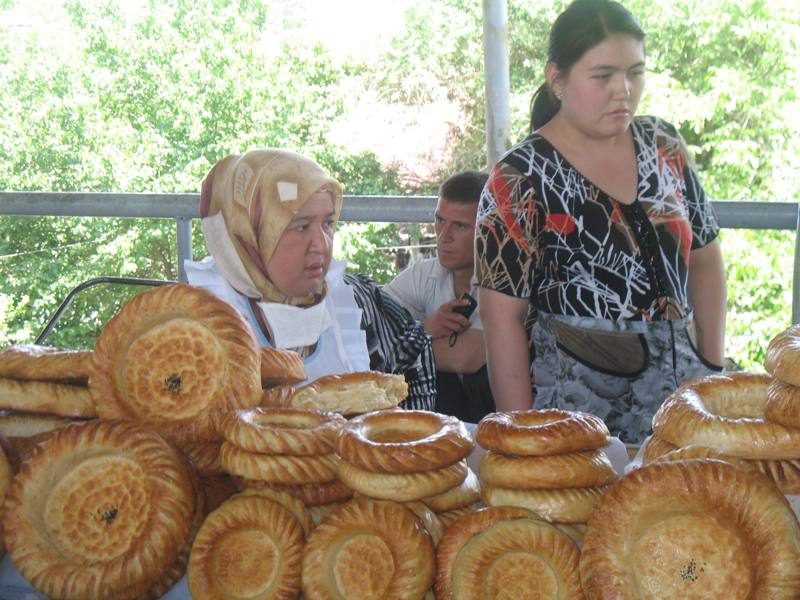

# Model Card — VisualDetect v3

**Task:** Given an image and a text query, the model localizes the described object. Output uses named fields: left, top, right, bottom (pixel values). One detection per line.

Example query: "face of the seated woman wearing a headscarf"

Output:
left=267, top=192, right=336, bottom=296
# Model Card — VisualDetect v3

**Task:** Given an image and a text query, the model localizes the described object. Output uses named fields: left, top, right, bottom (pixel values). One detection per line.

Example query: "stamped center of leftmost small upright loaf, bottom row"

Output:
left=213, top=529, right=282, bottom=598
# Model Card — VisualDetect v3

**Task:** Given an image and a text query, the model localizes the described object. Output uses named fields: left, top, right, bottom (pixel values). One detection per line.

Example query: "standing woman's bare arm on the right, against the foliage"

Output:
left=689, top=239, right=727, bottom=366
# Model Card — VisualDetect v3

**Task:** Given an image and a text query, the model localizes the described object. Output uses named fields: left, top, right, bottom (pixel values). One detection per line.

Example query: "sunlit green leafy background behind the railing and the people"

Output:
left=0, top=0, right=800, bottom=369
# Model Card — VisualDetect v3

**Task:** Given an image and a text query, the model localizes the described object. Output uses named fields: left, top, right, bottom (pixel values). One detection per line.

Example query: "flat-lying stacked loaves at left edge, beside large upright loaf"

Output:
left=0, top=344, right=97, bottom=462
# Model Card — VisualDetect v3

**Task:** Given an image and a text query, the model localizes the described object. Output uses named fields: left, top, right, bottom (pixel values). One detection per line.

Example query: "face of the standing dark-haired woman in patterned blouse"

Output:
left=548, top=34, right=644, bottom=138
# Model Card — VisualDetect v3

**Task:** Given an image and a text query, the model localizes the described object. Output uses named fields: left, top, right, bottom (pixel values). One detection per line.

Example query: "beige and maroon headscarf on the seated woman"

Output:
left=200, top=149, right=342, bottom=306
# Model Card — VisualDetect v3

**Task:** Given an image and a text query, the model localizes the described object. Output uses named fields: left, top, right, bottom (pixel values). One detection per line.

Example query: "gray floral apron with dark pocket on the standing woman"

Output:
left=531, top=312, right=721, bottom=444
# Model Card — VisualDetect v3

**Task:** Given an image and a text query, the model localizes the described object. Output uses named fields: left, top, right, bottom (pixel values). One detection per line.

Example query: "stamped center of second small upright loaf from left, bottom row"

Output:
left=334, top=533, right=395, bottom=600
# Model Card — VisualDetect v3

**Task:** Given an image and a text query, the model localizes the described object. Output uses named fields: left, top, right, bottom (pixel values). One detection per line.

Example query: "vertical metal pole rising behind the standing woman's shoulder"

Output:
left=483, top=0, right=510, bottom=169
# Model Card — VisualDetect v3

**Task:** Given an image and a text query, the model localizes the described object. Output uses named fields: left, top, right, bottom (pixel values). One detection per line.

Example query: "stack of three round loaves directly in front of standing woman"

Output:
left=476, top=409, right=616, bottom=523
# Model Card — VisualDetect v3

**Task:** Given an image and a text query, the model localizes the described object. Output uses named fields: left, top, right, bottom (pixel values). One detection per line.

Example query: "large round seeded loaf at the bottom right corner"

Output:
left=580, top=459, right=800, bottom=600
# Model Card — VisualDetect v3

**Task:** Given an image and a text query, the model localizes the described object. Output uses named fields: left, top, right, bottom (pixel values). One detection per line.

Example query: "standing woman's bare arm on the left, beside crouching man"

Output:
left=478, top=288, right=533, bottom=411
